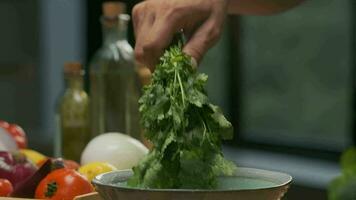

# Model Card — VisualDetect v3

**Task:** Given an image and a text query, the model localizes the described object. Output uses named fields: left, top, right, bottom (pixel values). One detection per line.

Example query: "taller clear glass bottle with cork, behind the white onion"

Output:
left=90, top=2, right=141, bottom=140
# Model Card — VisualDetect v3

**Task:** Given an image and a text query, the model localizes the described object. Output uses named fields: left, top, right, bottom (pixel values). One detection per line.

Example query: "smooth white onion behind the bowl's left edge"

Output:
left=81, top=133, right=148, bottom=169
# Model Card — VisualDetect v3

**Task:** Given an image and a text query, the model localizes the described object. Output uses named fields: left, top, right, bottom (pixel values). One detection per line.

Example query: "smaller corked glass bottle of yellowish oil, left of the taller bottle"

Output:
left=58, top=62, right=90, bottom=161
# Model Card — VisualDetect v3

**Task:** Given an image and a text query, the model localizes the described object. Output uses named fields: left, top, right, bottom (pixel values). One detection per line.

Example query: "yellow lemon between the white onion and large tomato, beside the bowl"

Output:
left=78, top=162, right=116, bottom=181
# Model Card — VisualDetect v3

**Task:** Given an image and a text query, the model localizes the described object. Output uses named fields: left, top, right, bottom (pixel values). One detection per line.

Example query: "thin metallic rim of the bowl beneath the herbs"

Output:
left=92, top=167, right=293, bottom=193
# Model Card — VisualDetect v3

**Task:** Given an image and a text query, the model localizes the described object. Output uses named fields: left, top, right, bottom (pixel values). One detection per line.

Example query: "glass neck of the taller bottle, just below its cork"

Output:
left=101, top=18, right=127, bottom=45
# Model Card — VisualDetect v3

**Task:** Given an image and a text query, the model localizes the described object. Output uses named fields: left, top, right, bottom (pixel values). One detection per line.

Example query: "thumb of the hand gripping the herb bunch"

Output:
left=183, top=17, right=222, bottom=63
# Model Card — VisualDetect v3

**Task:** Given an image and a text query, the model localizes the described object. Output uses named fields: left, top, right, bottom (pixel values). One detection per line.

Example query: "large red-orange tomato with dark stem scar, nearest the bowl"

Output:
left=35, top=168, right=94, bottom=200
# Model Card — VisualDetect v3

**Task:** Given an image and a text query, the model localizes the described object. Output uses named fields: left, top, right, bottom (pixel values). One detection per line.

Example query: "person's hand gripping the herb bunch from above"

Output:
left=132, top=0, right=228, bottom=70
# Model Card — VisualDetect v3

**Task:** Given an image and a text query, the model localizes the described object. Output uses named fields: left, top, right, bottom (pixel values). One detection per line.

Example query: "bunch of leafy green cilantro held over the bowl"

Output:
left=128, top=42, right=236, bottom=189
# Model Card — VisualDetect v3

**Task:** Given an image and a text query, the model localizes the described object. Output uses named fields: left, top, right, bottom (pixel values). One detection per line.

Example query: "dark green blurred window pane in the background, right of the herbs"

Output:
left=234, top=0, right=354, bottom=151
